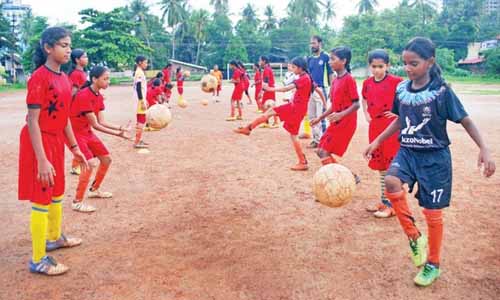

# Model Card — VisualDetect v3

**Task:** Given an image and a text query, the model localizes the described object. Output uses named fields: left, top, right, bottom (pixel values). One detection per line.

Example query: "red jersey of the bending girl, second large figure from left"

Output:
left=70, top=87, right=104, bottom=132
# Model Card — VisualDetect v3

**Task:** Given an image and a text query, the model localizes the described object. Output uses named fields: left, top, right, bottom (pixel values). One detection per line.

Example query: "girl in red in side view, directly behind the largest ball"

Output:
left=311, top=47, right=360, bottom=183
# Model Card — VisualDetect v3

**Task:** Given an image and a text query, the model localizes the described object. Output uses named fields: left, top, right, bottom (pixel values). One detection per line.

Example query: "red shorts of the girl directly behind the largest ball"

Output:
left=319, top=118, right=356, bottom=157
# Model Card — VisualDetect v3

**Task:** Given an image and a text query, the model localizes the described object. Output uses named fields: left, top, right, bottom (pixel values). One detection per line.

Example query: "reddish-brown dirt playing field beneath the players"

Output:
left=0, top=84, right=500, bottom=300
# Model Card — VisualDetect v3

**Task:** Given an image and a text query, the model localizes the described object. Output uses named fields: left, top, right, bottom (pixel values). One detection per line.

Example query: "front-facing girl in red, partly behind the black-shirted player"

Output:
left=362, top=49, right=403, bottom=218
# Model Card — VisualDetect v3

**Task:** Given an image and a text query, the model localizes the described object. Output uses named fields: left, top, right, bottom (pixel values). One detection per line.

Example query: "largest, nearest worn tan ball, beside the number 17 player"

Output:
left=313, top=164, right=356, bottom=207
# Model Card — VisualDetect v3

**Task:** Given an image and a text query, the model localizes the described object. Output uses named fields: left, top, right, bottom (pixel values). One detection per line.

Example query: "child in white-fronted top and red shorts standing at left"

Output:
left=134, top=55, right=148, bottom=149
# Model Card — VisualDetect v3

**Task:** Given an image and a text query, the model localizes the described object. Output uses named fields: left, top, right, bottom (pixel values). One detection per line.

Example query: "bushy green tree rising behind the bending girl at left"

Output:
left=73, top=8, right=152, bottom=70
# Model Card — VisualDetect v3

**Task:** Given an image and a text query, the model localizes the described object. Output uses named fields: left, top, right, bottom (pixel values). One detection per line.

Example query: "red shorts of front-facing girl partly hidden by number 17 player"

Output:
left=368, top=117, right=399, bottom=171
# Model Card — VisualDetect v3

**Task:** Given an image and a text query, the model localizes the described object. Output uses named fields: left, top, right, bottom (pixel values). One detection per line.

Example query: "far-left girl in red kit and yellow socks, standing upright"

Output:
left=19, top=27, right=88, bottom=275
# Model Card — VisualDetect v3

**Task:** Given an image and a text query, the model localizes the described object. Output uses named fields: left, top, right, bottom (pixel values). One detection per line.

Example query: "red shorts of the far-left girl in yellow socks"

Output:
left=18, top=126, right=64, bottom=205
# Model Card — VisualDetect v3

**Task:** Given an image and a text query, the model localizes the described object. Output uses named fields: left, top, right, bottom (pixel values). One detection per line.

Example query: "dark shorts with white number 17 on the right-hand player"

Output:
left=387, top=147, right=452, bottom=209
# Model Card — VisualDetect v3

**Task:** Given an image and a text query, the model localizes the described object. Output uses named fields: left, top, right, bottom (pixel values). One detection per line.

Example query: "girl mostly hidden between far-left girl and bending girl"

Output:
left=68, top=49, right=89, bottom=175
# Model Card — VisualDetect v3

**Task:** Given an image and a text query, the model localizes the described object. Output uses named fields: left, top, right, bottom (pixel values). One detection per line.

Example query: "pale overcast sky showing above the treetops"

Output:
left=22, top=0, right=400, bottom=28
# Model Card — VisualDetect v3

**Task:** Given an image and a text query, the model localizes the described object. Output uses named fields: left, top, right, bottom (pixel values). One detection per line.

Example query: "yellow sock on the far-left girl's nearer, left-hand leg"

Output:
left=30, top=203, right=49, bottom=263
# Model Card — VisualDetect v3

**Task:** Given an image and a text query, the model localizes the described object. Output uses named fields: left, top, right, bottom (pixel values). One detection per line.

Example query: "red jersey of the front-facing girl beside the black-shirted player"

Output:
left=362, top=74, right=403, bottom=119
